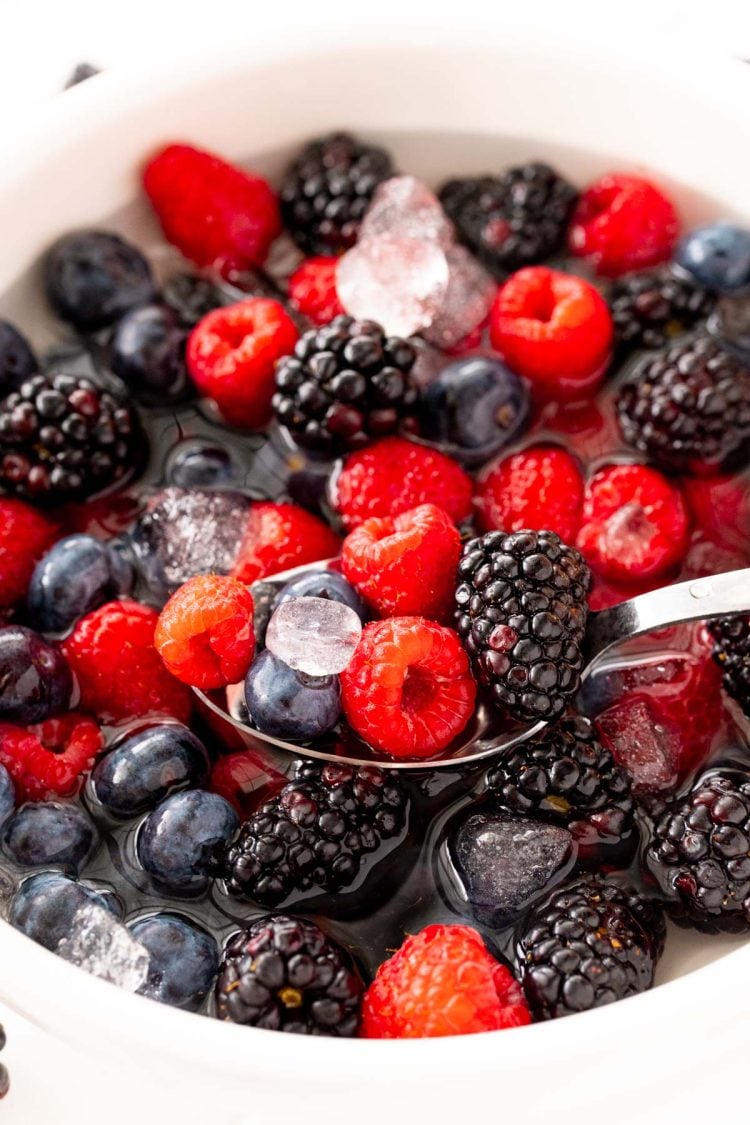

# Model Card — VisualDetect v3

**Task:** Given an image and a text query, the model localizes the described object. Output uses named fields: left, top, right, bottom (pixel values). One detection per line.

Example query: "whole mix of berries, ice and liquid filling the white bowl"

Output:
left=0, top=133, right=750, bottom=1044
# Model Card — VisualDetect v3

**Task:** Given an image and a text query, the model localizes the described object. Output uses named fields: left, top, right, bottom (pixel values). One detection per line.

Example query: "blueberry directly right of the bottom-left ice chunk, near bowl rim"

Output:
left=128, top=914, right=219, bottom=1011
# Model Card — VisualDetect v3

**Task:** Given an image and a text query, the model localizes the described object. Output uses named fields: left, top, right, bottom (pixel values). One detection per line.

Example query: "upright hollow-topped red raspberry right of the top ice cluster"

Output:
left=489, top=266, right=613, bottom=401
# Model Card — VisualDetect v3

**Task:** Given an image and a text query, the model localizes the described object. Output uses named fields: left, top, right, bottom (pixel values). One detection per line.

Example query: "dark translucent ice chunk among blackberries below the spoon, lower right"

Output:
left=452, top=813, right=577, bottom=926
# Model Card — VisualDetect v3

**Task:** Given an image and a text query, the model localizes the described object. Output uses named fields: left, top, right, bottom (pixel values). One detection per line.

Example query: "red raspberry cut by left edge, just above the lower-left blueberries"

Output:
left=0, top=711, right=103, bottom=803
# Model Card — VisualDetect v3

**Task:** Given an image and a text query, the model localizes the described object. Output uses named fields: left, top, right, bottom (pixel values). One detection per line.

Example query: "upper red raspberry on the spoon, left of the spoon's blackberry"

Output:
left=341, top=504, right=461, bottom=619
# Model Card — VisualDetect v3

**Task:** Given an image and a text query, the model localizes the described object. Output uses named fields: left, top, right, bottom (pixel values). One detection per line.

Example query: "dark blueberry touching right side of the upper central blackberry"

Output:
left=419, top=356, right=531, bottom=466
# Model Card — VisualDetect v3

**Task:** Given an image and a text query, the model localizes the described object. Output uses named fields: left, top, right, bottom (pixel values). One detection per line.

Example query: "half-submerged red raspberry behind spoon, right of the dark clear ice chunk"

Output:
left=232, top=502, right=341, bottom=586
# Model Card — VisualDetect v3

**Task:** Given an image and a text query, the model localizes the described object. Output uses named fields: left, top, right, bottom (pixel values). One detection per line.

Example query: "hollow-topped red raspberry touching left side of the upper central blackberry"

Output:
left=186, top=297, right=299, bottom=430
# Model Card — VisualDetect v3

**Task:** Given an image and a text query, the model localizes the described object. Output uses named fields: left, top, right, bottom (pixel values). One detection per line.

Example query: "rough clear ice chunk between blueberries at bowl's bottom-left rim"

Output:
left=55, top=902, right=151, bottom=992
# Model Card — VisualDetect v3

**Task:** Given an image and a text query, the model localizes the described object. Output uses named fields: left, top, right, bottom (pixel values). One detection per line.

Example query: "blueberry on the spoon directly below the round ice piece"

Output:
left=245, top=649, right=341, bottom=739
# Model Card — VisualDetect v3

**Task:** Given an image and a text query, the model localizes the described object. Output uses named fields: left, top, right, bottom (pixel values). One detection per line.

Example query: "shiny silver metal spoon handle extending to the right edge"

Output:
left=586, top=569, right=750, bottom=672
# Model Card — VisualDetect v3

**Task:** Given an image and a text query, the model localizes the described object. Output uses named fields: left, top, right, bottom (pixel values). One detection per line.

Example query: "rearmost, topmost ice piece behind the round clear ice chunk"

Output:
left=359, top=176, right=454, bottom=250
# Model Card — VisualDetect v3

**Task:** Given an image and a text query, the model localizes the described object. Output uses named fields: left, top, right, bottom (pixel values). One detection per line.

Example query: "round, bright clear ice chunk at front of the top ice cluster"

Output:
left=336, top=235, right=449, bottom=336
